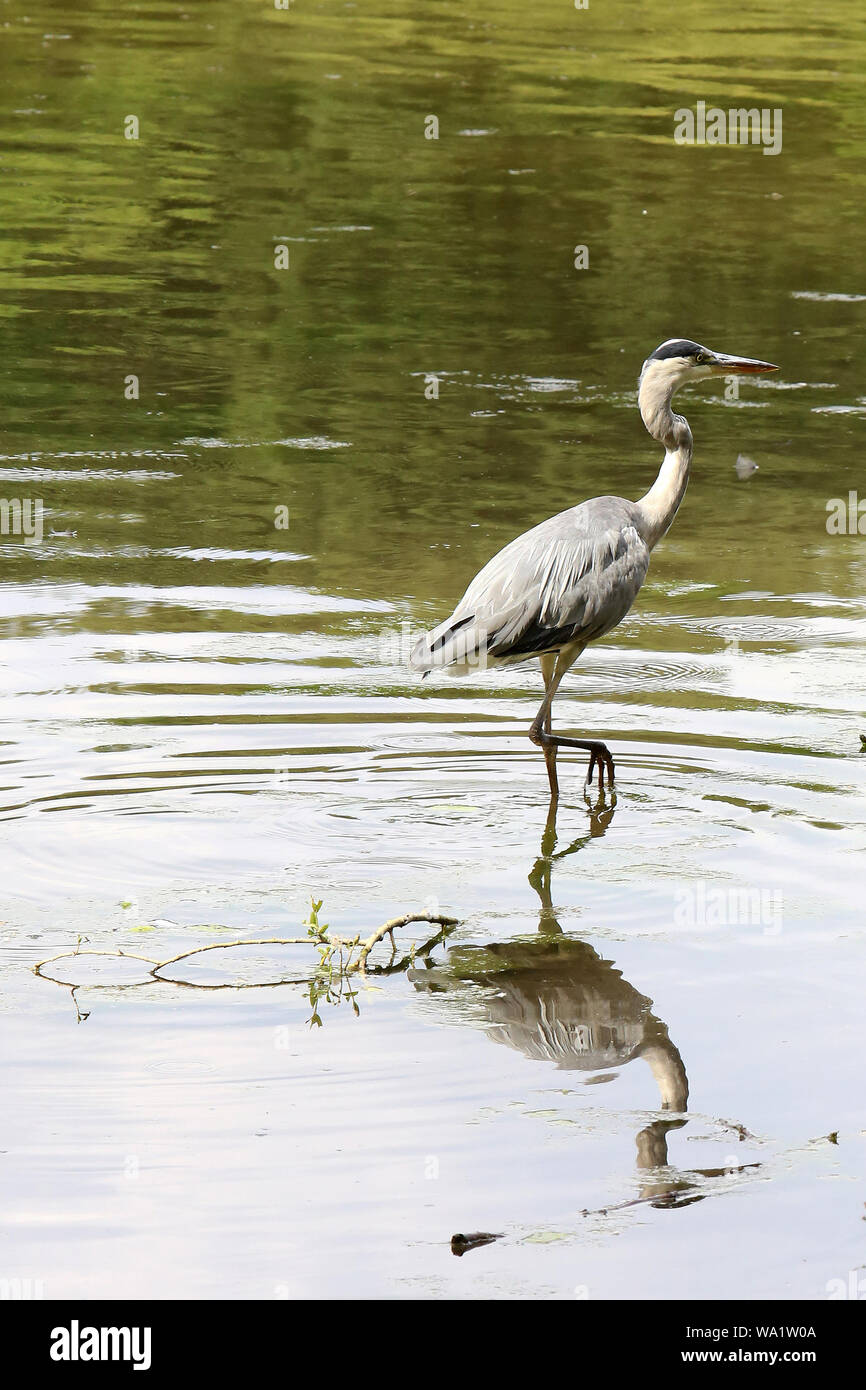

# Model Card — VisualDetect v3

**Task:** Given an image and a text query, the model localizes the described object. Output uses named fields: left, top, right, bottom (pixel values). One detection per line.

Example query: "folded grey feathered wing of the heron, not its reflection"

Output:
left=410, top=498, right=649, bottom=671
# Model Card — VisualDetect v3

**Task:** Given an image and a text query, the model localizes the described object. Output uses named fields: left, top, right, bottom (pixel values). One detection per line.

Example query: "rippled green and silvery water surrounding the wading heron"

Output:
left=0, top=0, right=866, bottom=1298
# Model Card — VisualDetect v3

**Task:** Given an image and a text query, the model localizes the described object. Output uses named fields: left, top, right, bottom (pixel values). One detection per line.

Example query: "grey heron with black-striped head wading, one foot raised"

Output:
left=410, top=338, right=778, bottom=801
